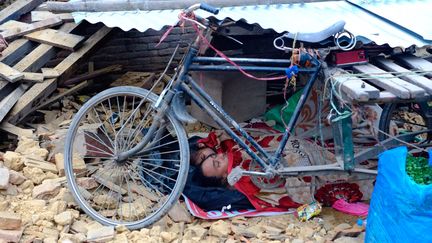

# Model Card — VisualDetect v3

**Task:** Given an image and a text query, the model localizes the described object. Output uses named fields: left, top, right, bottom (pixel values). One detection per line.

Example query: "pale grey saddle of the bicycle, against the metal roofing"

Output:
left=284, top=20, right=345, bottom=43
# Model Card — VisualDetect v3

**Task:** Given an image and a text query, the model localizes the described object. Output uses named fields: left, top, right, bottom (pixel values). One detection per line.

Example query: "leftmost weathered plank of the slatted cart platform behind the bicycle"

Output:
left=332, top=70, right=380, bottom=102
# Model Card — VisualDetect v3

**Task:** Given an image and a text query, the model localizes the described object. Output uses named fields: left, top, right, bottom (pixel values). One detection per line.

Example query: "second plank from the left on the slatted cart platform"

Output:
left=353, top=64, right=426, bottom=99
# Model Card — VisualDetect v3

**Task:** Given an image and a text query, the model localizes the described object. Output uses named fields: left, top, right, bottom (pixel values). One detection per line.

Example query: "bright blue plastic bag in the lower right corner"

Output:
left=365, top=147, right=432, bottom=243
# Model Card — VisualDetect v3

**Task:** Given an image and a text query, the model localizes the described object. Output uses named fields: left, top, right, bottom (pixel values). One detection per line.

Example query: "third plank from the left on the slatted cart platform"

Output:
left=374, top=57, right=432, bottom=94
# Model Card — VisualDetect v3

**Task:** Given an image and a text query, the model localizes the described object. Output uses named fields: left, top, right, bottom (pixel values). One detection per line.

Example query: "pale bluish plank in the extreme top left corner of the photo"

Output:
left=0, top=0, right=45, bottom=24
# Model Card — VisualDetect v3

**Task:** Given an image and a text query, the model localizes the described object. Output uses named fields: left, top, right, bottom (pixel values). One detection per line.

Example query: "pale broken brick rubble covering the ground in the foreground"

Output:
left=0, top=130, right=364, bottom=243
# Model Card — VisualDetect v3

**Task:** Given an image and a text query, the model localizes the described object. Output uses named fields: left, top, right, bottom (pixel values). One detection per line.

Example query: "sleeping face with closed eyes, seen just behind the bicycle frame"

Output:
left=195, top=148, right=228, bottom=178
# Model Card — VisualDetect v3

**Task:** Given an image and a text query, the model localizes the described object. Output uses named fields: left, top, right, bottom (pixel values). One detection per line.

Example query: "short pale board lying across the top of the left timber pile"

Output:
left=24, top=29, right=84, bottom=51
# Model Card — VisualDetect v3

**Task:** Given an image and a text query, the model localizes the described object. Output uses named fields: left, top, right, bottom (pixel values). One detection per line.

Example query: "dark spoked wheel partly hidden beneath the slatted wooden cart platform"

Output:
left=378, top=102, right=432, bottom=144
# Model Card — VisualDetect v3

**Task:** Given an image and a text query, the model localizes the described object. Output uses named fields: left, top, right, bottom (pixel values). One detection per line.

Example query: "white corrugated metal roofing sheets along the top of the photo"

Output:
left=73, top=0, right=432, bottom=47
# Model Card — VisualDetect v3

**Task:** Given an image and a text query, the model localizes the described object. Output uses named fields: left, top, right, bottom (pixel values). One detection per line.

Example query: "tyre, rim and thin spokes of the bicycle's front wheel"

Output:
left=64, top=86, right=189, bottom=229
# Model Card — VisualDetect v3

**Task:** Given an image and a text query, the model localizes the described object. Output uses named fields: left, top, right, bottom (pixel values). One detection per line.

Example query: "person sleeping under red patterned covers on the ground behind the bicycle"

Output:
left=183, top=128, right=335, bottom=210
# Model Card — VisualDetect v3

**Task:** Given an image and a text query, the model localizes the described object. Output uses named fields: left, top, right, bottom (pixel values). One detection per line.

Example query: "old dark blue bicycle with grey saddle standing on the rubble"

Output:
left=65, top=4, right=432, bottom=229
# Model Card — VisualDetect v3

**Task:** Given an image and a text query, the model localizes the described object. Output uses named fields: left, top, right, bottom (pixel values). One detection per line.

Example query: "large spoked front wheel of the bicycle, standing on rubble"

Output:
left=65, top=87, right=189, bottom=229
